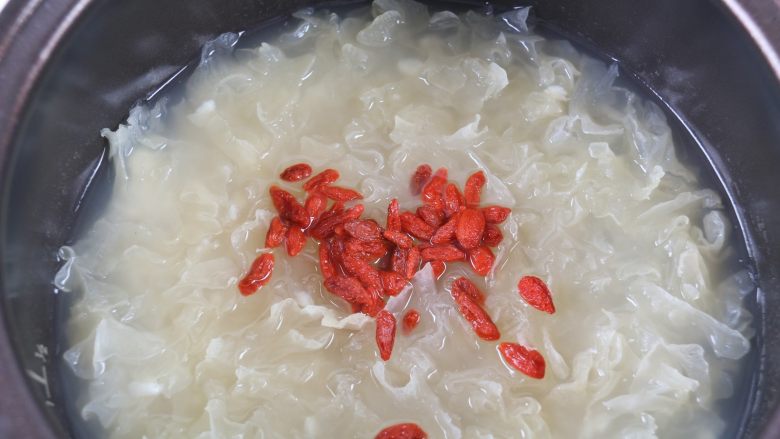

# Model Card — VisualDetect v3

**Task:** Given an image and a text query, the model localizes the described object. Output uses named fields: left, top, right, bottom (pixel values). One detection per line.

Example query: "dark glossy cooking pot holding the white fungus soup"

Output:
left=0, top=0, right=780, bottom=438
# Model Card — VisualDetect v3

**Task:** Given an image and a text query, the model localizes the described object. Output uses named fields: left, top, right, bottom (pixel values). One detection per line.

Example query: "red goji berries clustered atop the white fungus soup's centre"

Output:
left=238, top=163, right=555, bottom=400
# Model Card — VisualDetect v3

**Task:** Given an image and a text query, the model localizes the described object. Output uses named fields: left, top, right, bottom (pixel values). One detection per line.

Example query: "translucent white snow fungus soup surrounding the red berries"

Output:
left=56, top=0, right=753, bottom=438
